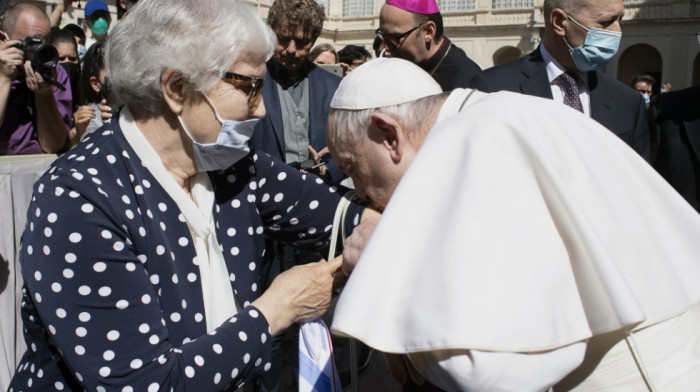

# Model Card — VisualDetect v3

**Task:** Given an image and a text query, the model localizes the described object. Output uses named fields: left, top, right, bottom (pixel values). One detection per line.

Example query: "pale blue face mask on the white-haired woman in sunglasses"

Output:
left=177, top=95, right=260, bottom=172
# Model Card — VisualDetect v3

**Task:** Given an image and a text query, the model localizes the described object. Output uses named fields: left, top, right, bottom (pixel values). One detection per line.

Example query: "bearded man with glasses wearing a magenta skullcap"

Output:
left=375, top=0, right=481, bottom=91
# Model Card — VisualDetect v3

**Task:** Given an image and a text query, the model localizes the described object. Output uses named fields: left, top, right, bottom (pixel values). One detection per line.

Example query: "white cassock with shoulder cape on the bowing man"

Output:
left=332, top=89, right=700, bottom=391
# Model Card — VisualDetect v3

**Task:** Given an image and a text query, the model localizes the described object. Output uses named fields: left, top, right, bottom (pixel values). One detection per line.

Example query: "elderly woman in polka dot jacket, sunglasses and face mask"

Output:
left=10, top=0, right=371, bottom=391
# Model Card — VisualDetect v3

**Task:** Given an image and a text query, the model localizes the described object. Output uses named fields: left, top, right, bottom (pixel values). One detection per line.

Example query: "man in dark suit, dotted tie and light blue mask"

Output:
left=470, top=0, right=650, bottom=160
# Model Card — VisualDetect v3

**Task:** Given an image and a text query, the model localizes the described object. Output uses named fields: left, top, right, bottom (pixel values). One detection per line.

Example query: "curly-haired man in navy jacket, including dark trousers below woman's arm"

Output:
left=250, top=0, right=344, bottom=392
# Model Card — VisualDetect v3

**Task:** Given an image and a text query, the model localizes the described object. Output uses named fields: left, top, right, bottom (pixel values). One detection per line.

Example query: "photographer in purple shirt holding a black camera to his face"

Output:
left=0, top=3, right=71, bottom=155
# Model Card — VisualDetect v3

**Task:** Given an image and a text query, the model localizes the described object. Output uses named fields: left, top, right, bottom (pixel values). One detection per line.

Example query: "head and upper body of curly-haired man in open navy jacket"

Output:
left=250, top=0, right=344, bottom=183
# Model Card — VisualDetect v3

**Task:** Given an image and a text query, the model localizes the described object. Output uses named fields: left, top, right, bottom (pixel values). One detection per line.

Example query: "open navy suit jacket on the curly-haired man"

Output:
left=250, top=59, right=344, bottom=184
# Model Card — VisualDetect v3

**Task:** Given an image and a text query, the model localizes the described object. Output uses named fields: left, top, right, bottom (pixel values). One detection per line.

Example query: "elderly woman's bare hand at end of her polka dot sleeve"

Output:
left=253, top=257, right=342, bottom=336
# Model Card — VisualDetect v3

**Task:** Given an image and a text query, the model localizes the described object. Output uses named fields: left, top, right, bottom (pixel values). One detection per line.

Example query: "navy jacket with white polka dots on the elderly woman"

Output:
left=9, top=121, right=362, bottom=392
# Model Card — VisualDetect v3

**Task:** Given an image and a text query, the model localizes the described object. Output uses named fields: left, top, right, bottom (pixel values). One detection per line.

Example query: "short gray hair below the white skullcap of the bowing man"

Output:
left=326, top=93, right=450, bottom=145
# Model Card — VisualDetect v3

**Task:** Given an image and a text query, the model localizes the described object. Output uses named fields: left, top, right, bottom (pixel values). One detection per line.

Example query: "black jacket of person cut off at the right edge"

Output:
left=649, top=86, right=700, bottom=212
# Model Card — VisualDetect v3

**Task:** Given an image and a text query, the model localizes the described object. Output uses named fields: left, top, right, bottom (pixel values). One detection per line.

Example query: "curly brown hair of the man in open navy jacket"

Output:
left=267, top=0, right=325, bottom=41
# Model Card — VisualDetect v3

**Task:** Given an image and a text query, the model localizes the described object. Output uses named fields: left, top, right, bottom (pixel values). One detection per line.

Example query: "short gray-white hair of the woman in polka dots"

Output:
left=106, top=0, right=277, bottom=114
